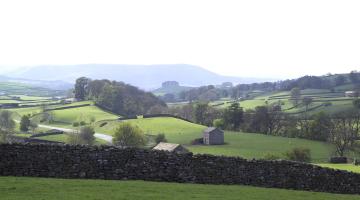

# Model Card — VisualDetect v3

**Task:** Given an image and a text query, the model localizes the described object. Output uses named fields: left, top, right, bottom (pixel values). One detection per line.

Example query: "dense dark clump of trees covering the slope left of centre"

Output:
left=74, top=77, right=166, bottom=116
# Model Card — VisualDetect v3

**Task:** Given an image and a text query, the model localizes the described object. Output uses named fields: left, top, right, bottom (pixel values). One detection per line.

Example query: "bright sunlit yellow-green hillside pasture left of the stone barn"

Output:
left=96, top=117, right=206, bottom=144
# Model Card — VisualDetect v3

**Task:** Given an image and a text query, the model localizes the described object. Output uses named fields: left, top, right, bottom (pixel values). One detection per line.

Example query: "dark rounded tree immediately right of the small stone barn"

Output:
left=223, top=102, right=244, bottom=130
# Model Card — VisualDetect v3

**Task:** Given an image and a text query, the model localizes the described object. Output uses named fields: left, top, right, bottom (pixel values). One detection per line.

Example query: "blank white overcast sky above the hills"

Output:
left=0, top=0, right=360, bottom=78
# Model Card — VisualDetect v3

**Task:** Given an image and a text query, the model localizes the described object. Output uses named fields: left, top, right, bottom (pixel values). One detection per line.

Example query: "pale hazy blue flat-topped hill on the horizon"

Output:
left=9, top=64, right=272, bottom=89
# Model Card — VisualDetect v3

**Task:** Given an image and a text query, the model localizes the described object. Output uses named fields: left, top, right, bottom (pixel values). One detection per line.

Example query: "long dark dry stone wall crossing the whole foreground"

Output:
left=0, top=144, right=360, bottom=194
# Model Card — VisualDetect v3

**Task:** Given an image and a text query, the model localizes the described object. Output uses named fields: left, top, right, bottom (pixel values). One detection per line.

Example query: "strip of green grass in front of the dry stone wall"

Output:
left=0, top=177, right=359, bottom=200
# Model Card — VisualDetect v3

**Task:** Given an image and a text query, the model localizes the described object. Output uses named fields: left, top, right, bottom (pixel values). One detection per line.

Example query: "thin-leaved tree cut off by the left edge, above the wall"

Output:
left=0, top=110, right=15, bottom=142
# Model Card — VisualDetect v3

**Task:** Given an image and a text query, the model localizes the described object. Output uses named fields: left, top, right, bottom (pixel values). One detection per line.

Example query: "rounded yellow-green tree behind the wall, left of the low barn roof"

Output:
left=113, top=122, right=146, bottom=147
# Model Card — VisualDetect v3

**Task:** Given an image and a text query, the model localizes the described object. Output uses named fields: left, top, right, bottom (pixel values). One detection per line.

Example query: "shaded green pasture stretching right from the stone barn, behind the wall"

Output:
left=187, top=131, right=334, bottom=163
